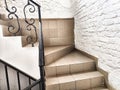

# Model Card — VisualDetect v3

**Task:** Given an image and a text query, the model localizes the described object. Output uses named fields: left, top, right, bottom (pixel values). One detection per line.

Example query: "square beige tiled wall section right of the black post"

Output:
left=43, top=19, right=74, bottom=46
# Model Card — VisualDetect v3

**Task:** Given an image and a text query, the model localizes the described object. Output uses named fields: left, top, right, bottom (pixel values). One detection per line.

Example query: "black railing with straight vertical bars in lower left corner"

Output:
left=0, top=59, right=36, bottom=90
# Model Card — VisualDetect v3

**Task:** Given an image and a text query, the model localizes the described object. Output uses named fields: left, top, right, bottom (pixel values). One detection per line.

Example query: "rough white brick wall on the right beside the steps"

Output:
left=73, top=0, right=120, bottom=90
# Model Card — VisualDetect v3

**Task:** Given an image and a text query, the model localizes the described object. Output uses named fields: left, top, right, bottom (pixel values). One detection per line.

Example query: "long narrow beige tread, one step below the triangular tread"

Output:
left=46, top=71, right=103, bottom=85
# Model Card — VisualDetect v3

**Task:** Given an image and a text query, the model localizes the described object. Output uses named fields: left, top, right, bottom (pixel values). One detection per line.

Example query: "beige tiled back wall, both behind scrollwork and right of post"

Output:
left=4, top=18, right=74, bottom=46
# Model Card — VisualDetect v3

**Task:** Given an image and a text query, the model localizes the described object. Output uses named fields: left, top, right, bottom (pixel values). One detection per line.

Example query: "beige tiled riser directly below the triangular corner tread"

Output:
left=45, top=62, right=96, bottom=77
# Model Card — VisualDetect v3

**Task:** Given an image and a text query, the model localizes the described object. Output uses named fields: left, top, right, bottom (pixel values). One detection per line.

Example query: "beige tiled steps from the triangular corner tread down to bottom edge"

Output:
left=45, top=50, right=108, bottom=90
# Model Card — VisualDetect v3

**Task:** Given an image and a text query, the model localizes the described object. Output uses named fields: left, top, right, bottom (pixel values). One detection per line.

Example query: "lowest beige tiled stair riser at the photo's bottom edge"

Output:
left=46, top=77, right=104, bottom=90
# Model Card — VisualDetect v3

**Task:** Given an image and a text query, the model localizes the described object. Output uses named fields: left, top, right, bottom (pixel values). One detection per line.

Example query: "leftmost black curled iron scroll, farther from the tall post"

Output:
left=5, top=0, right=20, bottom=35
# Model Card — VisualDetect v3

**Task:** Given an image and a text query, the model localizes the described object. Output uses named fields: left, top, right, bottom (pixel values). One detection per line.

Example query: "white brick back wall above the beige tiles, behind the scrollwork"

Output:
left=0, top=0, right=73, bottom=18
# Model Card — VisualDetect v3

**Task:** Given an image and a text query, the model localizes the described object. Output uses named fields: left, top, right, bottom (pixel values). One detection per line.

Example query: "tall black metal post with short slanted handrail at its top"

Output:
left=29, top=0, right=45, bottom=90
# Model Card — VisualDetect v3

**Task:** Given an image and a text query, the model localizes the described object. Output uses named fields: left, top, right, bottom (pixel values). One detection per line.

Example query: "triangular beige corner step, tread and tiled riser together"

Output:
left=45, top=50, right=96, bottom=77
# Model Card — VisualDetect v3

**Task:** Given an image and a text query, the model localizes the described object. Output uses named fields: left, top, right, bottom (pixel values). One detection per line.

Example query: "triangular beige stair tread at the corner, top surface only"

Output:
left=46, top=50, right=95, bottom=67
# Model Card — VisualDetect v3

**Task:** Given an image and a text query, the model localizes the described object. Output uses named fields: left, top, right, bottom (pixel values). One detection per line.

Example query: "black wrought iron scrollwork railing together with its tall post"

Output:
left=5, top=0, right=45, bottom=90
